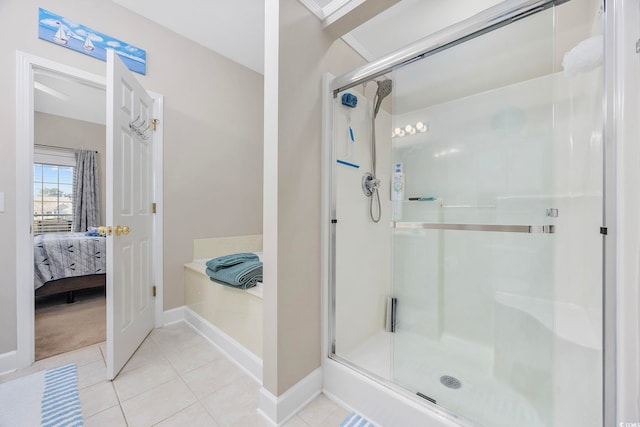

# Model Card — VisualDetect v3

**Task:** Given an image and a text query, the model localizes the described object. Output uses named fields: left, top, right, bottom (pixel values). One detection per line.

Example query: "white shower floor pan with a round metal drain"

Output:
left=345, top=332, right=551, bottom=427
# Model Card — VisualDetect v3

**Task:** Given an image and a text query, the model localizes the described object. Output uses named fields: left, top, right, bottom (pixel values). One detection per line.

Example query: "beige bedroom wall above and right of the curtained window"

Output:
left=33, top=112, right=106, bottom=225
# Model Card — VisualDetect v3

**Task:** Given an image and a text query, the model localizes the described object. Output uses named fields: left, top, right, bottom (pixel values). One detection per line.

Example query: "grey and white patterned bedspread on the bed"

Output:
left=33, top=233, right=107, bottom=289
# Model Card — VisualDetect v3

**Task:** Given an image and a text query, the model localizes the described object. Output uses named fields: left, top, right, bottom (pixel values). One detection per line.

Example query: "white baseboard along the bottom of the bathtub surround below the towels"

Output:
left=183, top=307, right=262, bottom=384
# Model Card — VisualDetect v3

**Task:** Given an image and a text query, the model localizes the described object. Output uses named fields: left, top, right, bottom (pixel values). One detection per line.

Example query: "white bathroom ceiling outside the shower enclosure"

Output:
left=112, top=0, right=510, bottom=74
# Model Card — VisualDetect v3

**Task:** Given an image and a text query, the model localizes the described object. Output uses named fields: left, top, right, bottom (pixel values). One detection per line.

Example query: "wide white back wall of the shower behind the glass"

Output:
left=393, top=69, right=602, bottom=425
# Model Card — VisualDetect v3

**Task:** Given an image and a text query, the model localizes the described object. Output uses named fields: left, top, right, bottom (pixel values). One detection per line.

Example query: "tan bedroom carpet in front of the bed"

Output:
left=35, top=287, right=107, bottom=360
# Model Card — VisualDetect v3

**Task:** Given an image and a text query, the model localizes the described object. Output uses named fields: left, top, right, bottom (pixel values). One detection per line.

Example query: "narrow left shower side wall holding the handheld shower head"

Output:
left=334, top=89, right=391, bottom=357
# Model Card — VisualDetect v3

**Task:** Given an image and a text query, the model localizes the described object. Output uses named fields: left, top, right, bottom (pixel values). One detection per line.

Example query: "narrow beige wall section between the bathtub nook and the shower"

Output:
left=263, top=0, right=364, bottom=396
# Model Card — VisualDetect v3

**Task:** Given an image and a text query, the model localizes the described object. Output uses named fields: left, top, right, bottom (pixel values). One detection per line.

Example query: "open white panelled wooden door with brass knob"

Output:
left=106, top=50, right=155, bottom=380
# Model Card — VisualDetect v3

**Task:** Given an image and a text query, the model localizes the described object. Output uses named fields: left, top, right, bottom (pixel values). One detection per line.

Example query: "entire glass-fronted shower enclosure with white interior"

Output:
left=329, top=0, right=604, bottom=427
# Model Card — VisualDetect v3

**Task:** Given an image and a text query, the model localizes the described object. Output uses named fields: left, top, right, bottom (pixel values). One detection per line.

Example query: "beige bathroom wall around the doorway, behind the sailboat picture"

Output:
left=0, top=0, right=263, bottom=354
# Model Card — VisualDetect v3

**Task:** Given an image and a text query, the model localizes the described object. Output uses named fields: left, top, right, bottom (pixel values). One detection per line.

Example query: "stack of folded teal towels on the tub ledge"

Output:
left=206, top=253, right=262, bottom=289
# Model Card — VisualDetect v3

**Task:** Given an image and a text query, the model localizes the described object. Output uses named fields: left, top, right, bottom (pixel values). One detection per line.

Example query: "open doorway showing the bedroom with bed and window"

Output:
left=33, top=69, right=108, bottom=361
